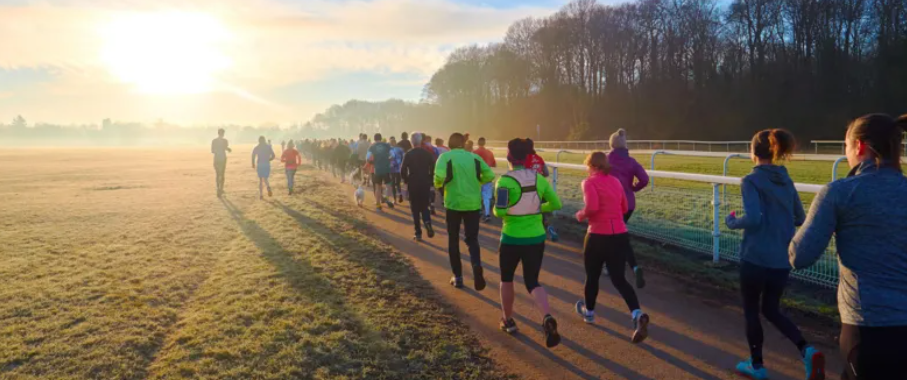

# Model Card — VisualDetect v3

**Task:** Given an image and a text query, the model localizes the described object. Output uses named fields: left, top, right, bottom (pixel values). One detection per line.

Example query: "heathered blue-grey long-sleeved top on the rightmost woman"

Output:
left=790, top=161, right=907, bottom=326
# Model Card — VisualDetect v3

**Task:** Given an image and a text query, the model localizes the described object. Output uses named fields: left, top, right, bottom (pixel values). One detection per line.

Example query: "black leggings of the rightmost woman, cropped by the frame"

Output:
left=839, top=324, right=907, bottom=380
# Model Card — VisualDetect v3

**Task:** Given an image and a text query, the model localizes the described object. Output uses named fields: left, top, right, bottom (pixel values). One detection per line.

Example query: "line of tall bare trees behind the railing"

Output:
left=312, top=0, right=907, bottom=140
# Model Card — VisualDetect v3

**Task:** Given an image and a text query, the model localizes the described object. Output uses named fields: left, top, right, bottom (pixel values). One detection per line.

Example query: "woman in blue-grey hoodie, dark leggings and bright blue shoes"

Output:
left=726, top=129, right=825, bottom=380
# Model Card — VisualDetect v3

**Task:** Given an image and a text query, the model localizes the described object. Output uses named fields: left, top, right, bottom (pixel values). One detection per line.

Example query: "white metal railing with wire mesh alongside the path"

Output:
left=499, top=155, right=838, bottom=287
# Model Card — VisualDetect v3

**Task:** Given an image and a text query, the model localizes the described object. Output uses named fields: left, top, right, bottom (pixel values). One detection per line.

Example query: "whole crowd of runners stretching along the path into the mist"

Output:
left=212, top=114, right=907, bottom=380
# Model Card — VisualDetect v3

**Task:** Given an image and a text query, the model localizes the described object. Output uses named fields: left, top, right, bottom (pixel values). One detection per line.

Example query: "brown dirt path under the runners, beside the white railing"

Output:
left=338, top=174, right=841, bottom=380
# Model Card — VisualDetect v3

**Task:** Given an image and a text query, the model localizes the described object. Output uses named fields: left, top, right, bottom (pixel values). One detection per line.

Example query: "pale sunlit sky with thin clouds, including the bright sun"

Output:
left=0, top=0, right=580, bottom=125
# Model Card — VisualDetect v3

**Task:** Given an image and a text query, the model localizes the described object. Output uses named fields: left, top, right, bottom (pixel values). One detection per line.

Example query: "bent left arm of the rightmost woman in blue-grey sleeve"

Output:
left=788, top=185, right=838, bottom=269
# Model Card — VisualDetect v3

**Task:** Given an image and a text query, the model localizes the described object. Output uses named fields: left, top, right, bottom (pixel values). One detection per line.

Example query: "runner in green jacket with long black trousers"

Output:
left=434, top=133, right=494, bottom=291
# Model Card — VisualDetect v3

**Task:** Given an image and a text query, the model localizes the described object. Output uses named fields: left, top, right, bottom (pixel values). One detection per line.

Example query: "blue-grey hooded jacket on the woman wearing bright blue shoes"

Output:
left=726, top=165, right=806, bottom=269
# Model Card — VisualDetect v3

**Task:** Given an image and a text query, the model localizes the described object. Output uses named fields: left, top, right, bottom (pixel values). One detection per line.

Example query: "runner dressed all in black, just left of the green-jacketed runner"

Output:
left=400, top=133, right=435, bottom=241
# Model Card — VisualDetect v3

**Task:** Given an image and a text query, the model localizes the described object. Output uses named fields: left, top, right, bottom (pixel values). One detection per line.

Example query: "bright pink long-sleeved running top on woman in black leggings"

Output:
left=576, top=173, right=629, bottom=235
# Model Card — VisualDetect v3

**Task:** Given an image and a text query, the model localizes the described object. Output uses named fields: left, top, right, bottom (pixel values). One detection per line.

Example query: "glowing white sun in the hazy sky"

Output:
left=101, top=12, right=231, bottom=95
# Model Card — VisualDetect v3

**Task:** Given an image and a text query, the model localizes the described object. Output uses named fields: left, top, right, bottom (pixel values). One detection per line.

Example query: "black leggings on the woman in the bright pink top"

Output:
left=583, top=233, right=639, bottom=312
